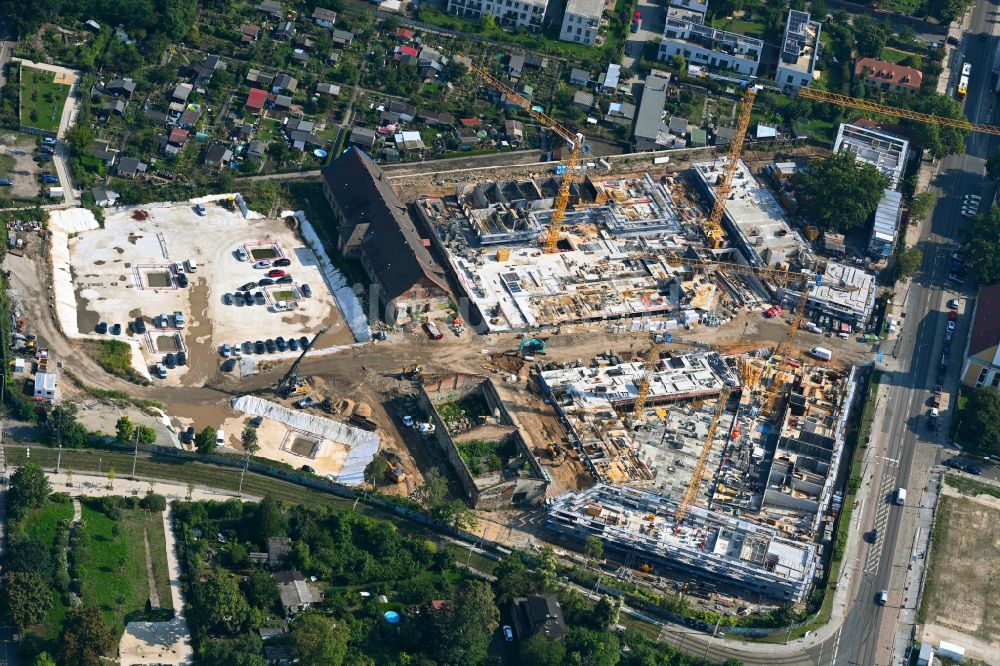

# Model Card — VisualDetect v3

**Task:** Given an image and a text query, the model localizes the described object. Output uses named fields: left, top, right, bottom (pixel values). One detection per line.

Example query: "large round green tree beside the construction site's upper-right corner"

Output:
left=797, top=152, right=889, bottom=233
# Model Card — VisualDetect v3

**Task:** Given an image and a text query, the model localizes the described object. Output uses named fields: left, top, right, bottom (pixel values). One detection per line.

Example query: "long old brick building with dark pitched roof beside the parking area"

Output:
left=323, top=148, right=449, bottom=324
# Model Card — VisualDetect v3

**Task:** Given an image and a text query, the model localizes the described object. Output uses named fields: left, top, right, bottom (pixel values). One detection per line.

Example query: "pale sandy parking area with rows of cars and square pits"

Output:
left=69, top=200, right=354, bottom=385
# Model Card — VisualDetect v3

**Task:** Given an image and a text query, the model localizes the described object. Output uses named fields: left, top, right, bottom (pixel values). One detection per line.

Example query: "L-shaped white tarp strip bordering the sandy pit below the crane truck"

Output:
left=232, top=395, right=382, bottom=485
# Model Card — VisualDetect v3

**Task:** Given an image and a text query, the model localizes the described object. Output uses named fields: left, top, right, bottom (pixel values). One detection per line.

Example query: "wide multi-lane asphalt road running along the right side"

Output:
left=834, top=1, right=997, bottom=664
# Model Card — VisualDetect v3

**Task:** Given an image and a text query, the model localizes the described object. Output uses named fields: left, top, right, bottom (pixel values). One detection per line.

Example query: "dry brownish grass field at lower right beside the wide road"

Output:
left=918, top=489, right=1000, bottom=647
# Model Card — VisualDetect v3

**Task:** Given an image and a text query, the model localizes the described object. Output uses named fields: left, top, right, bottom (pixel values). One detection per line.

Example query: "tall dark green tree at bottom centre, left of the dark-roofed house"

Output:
left=435, top=580, right=500, bottom=664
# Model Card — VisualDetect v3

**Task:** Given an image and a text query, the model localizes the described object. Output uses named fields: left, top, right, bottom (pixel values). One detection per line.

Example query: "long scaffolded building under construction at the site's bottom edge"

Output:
left=547, top=484, right=819, bottom=602
